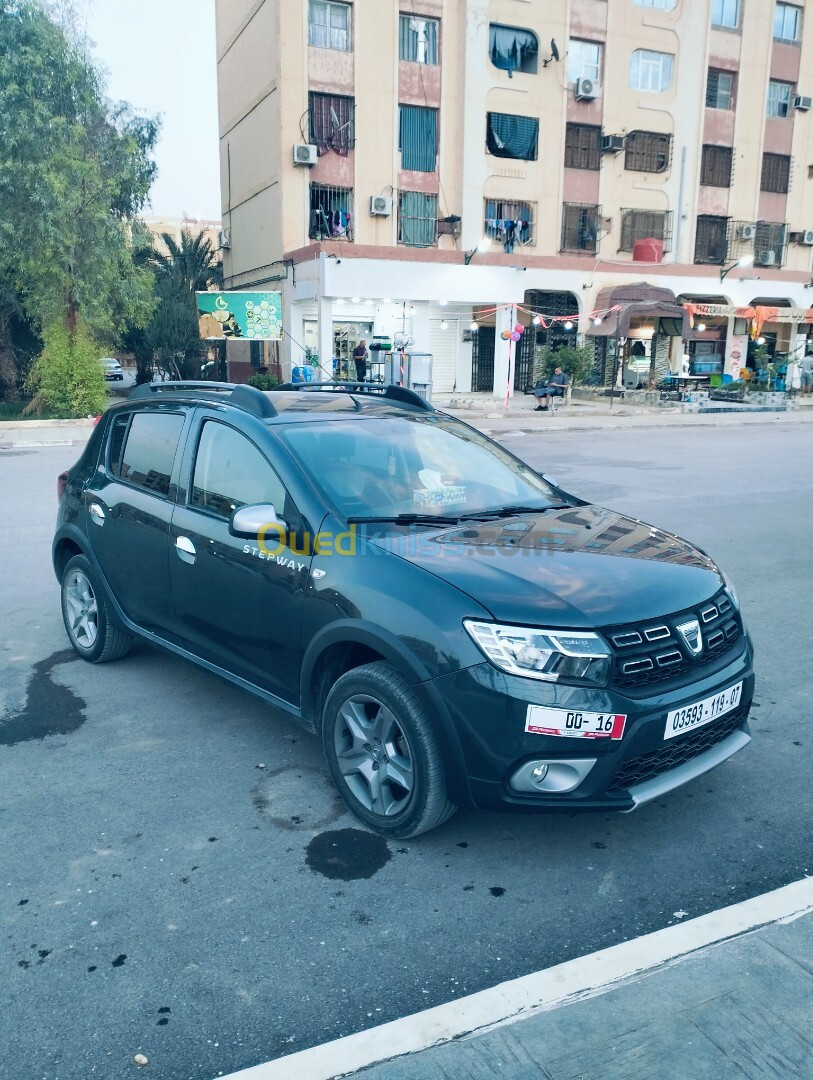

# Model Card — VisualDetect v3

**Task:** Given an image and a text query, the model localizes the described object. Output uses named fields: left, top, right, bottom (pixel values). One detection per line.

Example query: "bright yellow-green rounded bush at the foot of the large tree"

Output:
left=26, top=323, right=107, bottom=418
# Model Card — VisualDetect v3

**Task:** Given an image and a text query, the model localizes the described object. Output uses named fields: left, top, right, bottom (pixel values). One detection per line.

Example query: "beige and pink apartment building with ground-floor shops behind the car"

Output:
left=217, top=0, right=813, bottom=396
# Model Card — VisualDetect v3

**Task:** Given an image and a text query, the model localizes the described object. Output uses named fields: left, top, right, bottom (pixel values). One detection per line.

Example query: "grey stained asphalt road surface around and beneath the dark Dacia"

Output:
left=0, top=423, right=813, bottom=1080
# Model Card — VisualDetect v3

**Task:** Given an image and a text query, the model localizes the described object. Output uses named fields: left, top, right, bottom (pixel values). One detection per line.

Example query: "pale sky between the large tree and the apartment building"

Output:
left=83, top=0, right=220, bottom=219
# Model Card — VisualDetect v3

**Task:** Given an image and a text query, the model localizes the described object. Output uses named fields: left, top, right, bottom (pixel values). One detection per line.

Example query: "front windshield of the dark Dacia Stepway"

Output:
left=284, top=415, right=563, bottom=519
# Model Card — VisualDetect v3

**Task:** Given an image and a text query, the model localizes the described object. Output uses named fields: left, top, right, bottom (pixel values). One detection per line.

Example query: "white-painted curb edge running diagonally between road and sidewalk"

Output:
left=223, top=878, right=813, bottom=1080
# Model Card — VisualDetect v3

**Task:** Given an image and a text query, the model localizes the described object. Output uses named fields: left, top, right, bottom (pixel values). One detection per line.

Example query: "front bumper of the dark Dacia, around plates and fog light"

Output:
left=434, top=634, right=754, bottom=811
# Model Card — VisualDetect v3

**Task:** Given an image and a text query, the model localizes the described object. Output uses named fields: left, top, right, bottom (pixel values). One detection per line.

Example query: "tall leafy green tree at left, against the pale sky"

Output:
left=0, top=0, right=158, bottom=406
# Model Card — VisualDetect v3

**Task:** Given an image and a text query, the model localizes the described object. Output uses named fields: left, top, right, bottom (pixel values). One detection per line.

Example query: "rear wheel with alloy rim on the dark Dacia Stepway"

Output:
left=62, top=555, right=133, bottom=664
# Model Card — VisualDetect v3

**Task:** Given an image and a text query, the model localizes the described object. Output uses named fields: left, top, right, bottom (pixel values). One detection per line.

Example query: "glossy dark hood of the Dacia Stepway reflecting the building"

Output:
left=368, top=505, right=722, bottom=630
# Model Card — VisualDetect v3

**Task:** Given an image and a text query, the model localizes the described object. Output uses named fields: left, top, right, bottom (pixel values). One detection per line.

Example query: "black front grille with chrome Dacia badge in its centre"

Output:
left=602, top=592, right=743, bottom=689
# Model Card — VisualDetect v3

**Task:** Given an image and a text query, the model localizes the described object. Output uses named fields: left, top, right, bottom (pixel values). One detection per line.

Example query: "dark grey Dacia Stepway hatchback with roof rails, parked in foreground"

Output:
left=53, top=382, right=754, bottom=837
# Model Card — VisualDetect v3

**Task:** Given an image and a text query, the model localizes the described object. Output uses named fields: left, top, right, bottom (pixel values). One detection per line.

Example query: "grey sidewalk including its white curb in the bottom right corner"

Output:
left=227, top=878, right=813, bottom=1080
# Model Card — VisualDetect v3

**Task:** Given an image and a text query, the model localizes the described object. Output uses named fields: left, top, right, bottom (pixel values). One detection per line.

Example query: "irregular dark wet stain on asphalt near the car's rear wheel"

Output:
left=0, top=649, right=85, bottom=746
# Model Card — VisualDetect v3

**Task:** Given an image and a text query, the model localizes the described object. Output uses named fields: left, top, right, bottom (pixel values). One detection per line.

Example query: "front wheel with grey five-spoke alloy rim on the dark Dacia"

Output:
left=322, top=662, right=457, bottom=839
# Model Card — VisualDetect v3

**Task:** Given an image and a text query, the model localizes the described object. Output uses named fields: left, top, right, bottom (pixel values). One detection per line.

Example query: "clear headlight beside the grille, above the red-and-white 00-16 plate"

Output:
left=463, top=619, right=612, bottom=686
